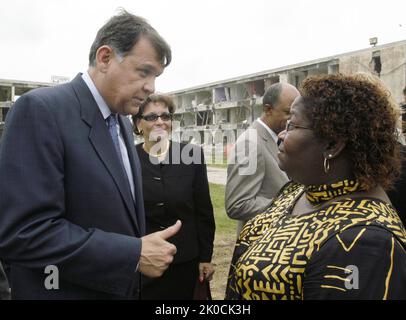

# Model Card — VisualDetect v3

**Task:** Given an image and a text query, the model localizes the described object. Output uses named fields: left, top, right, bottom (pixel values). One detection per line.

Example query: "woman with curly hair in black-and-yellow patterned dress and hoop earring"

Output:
left=226, top=74, right=406, bottom=300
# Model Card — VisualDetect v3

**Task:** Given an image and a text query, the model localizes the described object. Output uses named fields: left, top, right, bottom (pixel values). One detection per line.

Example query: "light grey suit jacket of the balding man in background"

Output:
left=225, top=120, right=288, bottom=234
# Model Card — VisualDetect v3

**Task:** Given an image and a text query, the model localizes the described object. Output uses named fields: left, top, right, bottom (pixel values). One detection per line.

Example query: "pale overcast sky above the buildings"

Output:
left=0, top=0, right=406, bottom=92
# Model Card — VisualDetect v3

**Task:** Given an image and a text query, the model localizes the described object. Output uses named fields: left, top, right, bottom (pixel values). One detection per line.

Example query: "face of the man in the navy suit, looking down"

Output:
left=101, top=38, right=164, bottom=115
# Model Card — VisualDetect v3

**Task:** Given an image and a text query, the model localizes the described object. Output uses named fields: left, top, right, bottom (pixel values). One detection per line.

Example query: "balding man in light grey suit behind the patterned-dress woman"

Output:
left=225, top=83, right=299, bottom=234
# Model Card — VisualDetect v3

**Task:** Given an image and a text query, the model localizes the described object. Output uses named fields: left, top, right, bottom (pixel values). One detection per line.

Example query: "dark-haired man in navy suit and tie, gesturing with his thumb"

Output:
left=0, top=11, right=180, bottom=299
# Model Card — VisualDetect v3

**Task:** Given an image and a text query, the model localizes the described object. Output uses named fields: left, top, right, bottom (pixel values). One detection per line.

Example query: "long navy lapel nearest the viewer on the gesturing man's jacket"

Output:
left=71, top=74, right=140, bottom=235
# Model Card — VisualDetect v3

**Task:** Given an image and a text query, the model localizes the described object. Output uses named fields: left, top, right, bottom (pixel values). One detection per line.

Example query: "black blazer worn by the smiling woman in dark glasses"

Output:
left=136, top=142, right=215, bottom=263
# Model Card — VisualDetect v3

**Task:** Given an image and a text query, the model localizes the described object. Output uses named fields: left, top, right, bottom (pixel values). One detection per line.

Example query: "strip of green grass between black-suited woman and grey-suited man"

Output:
left=210, top=183, right=237, bottom=236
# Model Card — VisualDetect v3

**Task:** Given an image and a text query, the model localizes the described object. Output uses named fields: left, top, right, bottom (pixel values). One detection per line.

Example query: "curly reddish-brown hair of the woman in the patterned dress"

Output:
left=300, top=74, right=401, bottom=190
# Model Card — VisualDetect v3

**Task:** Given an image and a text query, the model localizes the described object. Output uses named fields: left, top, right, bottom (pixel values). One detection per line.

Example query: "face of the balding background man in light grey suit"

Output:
left=269, top=86, right=299, bottom=134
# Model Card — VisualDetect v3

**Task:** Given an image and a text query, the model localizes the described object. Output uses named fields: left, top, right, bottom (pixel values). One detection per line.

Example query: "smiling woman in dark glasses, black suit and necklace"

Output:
left=133, top=94, right=215, bottom=300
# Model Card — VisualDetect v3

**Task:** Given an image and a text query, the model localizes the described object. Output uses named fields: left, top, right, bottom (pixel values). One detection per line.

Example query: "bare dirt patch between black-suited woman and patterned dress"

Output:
left=210, top=234, right=236, bottom=300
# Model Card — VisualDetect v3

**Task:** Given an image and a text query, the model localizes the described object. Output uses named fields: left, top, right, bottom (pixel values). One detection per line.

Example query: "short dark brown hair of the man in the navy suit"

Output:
left=89, top=9, right=172, bottom=67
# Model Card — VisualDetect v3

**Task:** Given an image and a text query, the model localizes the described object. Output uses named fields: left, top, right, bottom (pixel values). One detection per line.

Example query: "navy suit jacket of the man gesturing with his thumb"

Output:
left=0, top=75, right=145, bottom=299
